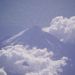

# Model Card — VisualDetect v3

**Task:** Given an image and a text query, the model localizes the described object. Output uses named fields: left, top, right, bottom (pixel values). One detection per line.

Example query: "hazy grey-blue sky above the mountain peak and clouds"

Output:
left=0, top=0, right=75, bottom=38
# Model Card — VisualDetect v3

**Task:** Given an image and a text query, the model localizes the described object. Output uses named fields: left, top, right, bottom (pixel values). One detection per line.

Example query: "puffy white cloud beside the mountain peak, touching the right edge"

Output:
left=43, top=16, right=75, bottom=42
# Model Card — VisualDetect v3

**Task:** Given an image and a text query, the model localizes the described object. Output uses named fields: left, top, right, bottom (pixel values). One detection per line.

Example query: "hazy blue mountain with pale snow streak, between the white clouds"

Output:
left=0, top=26, right=75, bottom=75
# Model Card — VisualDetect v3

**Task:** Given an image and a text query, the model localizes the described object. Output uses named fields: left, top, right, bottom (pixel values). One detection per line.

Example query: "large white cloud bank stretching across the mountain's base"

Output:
left=0, top=45, right=68, bottom=75
